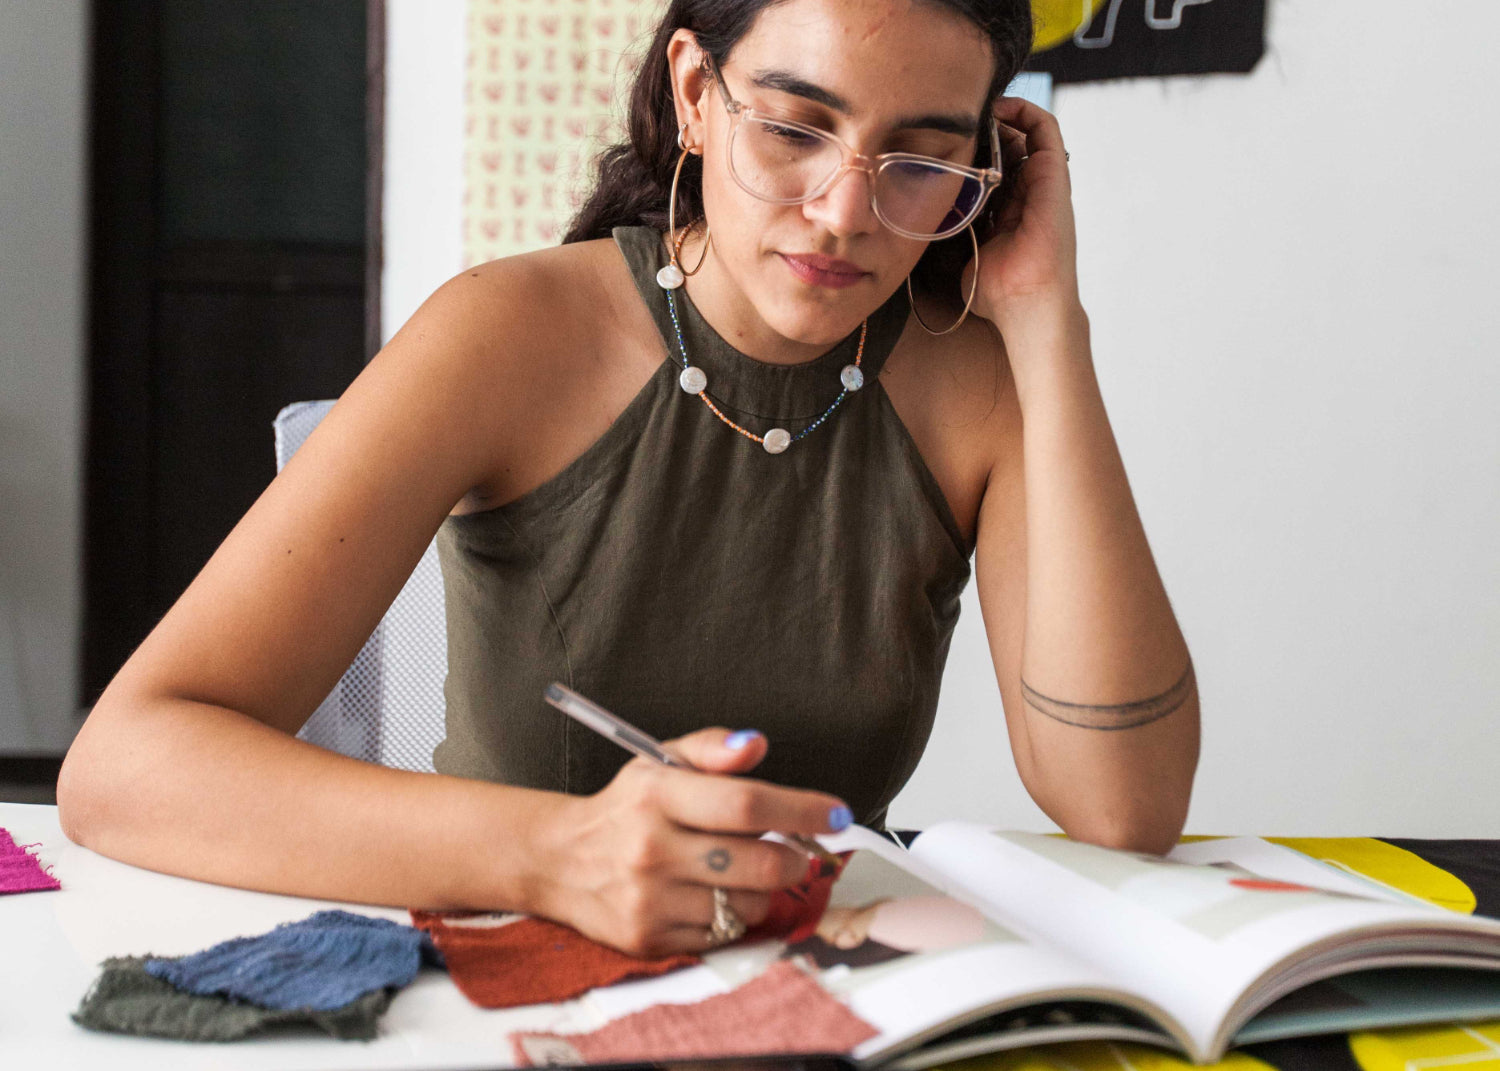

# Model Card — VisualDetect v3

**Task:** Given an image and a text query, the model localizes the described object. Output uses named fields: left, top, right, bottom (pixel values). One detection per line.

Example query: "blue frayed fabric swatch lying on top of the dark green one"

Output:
left=146, top=911, right=441, bottom=1011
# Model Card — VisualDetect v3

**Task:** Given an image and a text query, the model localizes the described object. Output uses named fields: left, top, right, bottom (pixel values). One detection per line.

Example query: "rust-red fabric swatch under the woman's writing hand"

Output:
left=411, top=911, right=701, bottom=1008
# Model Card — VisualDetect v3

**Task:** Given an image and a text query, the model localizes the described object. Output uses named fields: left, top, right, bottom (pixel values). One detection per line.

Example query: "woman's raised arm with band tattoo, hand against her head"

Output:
left=963, top=98, right=1199, bottom=852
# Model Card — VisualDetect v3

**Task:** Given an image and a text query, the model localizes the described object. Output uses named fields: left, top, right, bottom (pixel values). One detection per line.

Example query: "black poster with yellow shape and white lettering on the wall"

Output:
left=1026, top=0, right=1266, bottom=84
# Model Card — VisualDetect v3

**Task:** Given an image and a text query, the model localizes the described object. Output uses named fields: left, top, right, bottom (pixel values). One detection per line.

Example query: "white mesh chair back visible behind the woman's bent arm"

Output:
left=276, top=401, right=449, bottom=771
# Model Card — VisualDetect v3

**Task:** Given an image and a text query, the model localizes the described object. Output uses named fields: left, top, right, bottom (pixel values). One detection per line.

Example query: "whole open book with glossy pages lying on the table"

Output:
left=524, top=822, right=1500, bottom=1071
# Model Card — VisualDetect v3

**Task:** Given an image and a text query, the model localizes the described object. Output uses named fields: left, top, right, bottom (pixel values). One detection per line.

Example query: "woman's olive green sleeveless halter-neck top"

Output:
left=434, top=227, right=972, bottom=827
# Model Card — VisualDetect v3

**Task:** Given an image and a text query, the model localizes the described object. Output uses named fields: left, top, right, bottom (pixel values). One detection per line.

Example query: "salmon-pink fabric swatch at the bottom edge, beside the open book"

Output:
left=510, top=960, right=879, bottom=1067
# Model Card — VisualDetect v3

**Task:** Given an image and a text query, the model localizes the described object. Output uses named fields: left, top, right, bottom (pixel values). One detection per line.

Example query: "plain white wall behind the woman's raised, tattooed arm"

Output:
left=893, top=0, right=1500, bottom=837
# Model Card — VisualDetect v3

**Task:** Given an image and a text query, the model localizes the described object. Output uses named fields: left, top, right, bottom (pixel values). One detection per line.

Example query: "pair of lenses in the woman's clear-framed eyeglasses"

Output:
left=729, top=117, right=984, bottom=234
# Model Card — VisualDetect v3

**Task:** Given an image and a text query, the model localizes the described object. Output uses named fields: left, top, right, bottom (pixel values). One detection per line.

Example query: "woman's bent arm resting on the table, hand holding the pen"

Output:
left=57, top=258, right=837, bottom=951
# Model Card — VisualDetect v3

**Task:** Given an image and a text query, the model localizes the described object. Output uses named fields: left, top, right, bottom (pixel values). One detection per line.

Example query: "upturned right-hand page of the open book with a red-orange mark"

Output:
left=912, top=822, right=1500, bottom=1055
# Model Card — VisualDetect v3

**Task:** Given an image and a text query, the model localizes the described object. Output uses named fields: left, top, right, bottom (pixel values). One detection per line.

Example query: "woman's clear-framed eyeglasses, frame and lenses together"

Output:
left=704, top=53, right=1001, bottom=242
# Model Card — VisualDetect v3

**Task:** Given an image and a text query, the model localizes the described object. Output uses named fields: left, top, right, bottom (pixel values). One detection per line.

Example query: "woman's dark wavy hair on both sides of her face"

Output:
left=563, top=0, right=1032, bottom=305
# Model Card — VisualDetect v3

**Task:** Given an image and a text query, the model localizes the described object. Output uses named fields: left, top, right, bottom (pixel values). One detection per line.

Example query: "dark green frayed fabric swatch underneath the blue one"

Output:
left=72, top=956, right=392, bottom=1041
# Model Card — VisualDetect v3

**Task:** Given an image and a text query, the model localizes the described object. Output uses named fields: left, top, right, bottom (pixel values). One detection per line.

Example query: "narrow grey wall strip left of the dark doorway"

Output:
left=0, top=0, right=89, bottom=753
